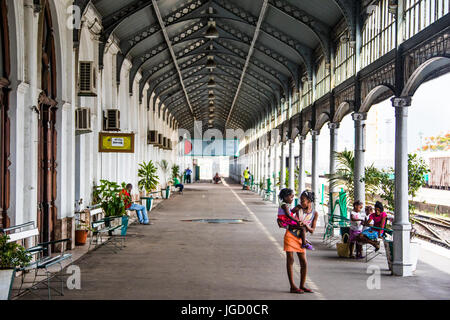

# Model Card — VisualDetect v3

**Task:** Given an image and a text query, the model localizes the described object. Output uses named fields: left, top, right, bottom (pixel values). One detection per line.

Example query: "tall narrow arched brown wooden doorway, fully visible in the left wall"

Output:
left=37, top=3, right=57, bottom=246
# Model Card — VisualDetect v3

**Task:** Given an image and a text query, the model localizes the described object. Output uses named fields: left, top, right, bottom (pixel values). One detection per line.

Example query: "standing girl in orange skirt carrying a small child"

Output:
left=284, top=191, right=318, bottom=293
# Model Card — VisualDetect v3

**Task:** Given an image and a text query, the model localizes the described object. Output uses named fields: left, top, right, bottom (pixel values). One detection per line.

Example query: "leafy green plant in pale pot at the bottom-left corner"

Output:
left=0, top=234, right=31, bottom=300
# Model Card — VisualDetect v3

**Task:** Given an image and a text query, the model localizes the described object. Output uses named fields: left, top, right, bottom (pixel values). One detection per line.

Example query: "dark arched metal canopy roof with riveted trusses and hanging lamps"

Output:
left=75, top=0, right=357, bottom=132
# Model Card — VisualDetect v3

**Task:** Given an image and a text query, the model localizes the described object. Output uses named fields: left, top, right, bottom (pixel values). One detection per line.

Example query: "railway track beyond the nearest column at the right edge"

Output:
left=412, top=214, right=450, bottom=249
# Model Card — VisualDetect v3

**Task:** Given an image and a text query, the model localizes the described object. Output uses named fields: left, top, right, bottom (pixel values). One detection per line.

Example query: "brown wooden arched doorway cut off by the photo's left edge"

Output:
left=0, top=0, right=10, bottom=228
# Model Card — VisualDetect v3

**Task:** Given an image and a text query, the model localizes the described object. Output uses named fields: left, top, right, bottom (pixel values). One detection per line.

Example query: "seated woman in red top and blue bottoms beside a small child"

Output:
left=357, top=201, right=387, bottom=251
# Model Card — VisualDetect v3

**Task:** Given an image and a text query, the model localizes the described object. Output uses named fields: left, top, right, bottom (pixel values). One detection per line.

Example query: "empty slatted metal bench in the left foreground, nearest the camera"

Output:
left=0, top=222, right=72, bottom=300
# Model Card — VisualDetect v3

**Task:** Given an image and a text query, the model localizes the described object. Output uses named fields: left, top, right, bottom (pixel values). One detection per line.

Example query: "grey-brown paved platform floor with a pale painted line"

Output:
left=17, top=182, right=450, bottom=300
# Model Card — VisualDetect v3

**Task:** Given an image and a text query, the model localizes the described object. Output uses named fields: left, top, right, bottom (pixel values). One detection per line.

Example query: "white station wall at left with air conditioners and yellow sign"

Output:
left=7, top=0, right=182, bottom=230
